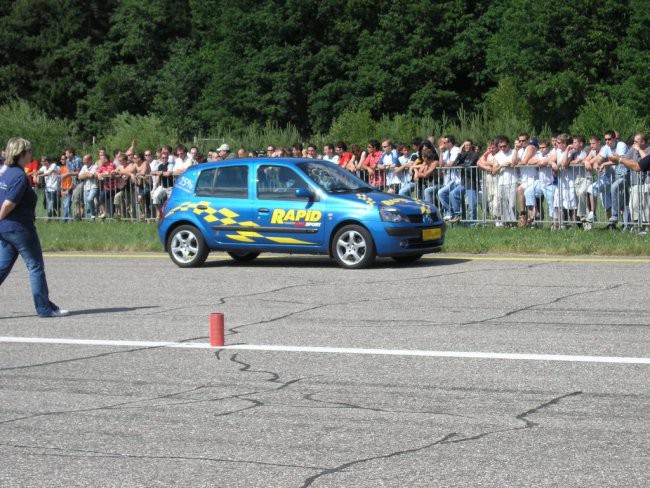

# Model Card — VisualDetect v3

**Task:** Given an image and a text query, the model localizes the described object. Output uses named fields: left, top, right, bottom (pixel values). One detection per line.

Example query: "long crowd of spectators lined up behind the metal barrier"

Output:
left=2, top=131, right=650, bottom=230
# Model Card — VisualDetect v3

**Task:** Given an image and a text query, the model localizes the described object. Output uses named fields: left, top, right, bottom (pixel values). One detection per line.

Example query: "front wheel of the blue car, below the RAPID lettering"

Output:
left=331, top=224, right=376, bottom=269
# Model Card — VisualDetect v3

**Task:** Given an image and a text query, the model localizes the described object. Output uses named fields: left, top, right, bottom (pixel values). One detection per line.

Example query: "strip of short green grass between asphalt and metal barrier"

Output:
left=36, top=220, right=650, bottom=256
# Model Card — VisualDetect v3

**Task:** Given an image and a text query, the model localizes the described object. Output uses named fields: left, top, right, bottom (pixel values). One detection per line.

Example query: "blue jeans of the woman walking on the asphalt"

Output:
left=0, top=229, right=59, bottom=316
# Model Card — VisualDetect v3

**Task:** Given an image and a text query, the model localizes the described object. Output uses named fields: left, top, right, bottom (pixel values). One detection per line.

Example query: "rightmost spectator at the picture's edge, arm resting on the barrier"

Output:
left=609, top=132, right=650, bottom=231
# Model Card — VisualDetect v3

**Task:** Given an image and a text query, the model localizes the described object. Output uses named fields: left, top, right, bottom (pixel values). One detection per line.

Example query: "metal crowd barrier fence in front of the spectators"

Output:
left=35, top=165, right=650, bottom=231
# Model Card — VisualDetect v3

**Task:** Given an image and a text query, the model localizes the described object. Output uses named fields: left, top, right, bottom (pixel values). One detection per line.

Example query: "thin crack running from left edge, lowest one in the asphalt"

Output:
left=0, top=442, right=324, bottom=470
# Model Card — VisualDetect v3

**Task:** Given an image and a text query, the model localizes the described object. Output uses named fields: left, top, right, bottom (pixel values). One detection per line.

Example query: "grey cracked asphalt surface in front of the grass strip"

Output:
left=0, top=254, right=650, bottom=487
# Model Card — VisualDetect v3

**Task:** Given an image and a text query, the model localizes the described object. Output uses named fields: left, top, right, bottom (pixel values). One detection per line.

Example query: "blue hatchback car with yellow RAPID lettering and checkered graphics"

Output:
left=158, top=158, right=445, bottom=269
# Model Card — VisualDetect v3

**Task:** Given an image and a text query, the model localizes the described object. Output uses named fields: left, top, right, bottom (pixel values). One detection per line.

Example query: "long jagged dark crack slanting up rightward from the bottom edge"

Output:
left=301, top=391, right=582, bottom=488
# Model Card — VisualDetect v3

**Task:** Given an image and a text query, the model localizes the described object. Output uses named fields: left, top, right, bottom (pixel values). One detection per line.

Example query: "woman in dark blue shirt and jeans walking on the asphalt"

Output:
left=0, top=138, right=69, bottom=317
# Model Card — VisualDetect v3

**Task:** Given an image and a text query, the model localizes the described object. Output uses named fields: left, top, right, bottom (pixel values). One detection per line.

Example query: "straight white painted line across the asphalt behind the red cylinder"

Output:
left=0, top=337, right=650, bottom=364
